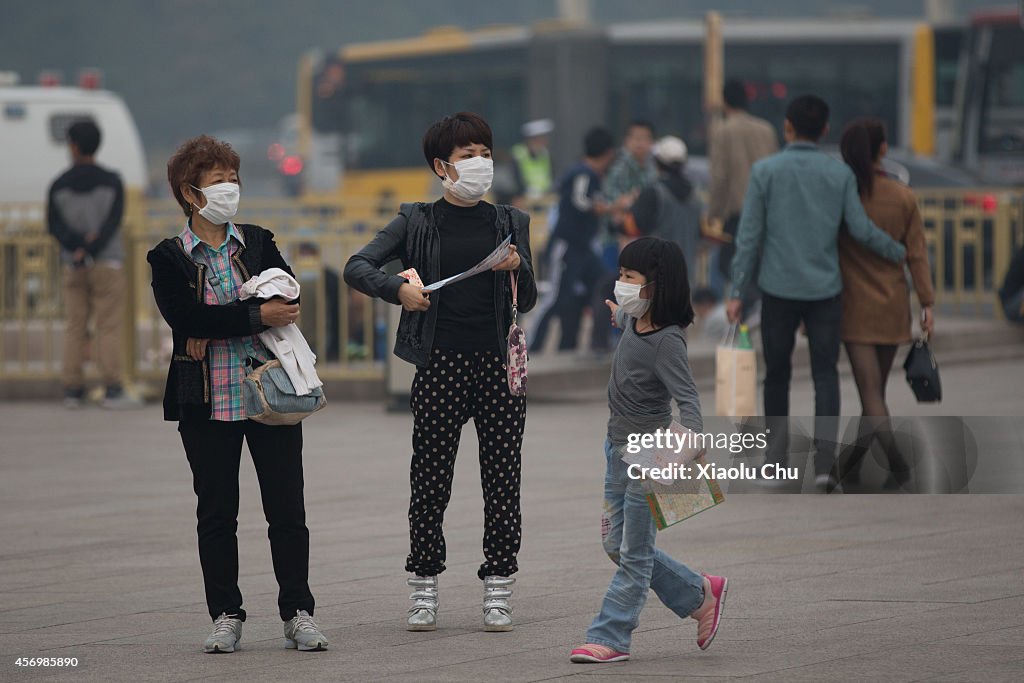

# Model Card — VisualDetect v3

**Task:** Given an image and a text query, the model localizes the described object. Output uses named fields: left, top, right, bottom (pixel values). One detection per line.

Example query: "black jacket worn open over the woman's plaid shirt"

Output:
left=146, top=224, right=295, bottom=421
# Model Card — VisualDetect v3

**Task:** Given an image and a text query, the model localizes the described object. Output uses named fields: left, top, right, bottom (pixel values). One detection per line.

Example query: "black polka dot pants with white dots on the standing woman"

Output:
left=406, top=349, right=526, bottom=579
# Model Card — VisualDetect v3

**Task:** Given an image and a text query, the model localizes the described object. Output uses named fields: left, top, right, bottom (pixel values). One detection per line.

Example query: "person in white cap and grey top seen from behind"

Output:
left=626, top=135, right=702, bottom=289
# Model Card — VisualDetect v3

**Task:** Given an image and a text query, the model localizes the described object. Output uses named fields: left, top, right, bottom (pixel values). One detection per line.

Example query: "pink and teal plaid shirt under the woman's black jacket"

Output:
left=178, top=223, right=270, bottom=422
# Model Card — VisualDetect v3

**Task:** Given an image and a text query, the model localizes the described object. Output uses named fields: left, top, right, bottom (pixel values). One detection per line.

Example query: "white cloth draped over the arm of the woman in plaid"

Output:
left=239, top=268, right=324, bottom=396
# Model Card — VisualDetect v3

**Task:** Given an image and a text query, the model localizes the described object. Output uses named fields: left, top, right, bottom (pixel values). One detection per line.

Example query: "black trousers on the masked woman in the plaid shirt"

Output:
left=178, top=420, right=314, bottom=622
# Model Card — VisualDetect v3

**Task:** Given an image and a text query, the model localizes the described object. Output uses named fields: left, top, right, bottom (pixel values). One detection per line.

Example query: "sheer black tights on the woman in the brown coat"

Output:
left=835, top=342, right=907, bottom=483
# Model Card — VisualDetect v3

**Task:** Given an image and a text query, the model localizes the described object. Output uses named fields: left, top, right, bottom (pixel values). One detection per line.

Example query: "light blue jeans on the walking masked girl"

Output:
left=587, top=440, right=703, bottom=652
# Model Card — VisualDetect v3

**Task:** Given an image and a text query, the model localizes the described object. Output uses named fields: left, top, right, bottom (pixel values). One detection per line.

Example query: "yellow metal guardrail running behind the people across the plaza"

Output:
left=0, top=188, right=1024, bottom=387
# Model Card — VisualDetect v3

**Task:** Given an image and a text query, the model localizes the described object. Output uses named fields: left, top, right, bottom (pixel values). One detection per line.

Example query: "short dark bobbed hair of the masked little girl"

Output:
left=618, top=237, right=693, bottom=328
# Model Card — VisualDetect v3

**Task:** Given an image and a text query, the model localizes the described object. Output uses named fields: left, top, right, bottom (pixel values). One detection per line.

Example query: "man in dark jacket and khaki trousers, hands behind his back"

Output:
left=46, top=121, right=141, bottom=409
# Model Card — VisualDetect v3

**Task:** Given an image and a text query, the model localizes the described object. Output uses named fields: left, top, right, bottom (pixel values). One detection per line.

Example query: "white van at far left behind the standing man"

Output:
left=0, top=86, right=146, bottom=203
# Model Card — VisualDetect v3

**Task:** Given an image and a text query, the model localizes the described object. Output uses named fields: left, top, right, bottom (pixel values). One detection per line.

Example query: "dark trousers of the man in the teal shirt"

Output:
left=761, top=293, right=843, bottom=474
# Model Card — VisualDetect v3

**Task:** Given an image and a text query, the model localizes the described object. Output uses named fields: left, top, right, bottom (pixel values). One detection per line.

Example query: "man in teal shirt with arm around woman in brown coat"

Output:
left=727, top=95, right=906, bottom=487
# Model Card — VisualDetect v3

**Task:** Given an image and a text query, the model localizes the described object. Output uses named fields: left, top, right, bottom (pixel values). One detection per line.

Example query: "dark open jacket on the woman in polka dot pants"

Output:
left=345, top=201, right=537, bottom=368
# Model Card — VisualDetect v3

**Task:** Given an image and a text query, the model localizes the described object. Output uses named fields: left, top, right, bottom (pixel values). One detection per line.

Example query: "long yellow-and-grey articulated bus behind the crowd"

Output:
left=297, top=18, right=999, bottom=211
